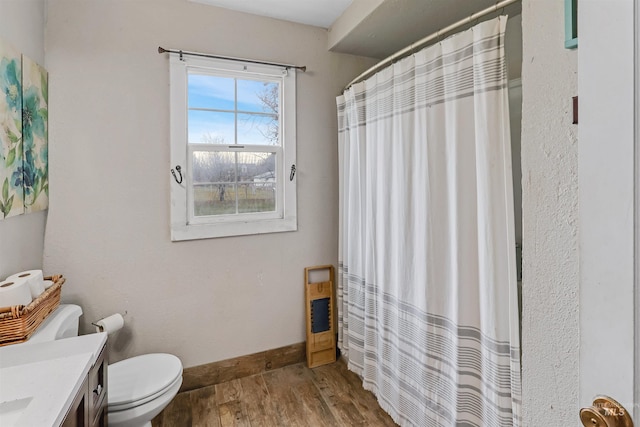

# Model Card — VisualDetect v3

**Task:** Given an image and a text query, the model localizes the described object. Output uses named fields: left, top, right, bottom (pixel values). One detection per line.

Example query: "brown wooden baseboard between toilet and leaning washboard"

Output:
left=180, top=342, right=306, bottom=392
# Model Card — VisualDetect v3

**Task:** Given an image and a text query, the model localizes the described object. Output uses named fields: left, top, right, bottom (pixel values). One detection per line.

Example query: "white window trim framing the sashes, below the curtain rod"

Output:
left=169, top=55, right=298, bottom=241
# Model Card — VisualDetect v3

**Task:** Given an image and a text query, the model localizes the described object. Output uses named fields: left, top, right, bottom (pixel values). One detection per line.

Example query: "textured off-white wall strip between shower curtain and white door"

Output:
left=521, top=0, right=580, bottom=426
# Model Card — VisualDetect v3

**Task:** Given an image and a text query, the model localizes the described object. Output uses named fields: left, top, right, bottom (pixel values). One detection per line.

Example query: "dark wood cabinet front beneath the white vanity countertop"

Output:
left=62, top=344, right=108, bottom=427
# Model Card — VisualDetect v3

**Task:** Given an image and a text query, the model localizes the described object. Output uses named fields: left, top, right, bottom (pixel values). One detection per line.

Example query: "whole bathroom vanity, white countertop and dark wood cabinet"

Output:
left=0, top=333, right=107, bottom=427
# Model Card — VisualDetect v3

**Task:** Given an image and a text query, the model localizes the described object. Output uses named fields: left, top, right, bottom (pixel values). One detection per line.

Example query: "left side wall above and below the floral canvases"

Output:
left=0, top=0, right=47, bottom=279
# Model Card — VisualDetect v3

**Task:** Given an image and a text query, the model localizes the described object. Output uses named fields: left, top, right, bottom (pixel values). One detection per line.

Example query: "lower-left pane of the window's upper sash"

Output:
left=188, top=110, right=235, bottom=145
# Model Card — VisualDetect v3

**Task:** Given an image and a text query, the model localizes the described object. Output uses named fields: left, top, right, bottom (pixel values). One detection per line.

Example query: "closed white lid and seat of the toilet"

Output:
left=107, top=353, right=182, bottom=407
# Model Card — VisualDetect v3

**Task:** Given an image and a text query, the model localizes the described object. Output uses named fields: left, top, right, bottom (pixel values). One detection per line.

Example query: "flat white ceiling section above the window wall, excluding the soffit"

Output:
left=191, top=0, right=352, bottom=28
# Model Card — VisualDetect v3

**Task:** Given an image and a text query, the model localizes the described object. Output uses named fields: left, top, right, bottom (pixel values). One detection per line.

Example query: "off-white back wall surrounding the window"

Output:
left=44, top=0, right=372, bottom=366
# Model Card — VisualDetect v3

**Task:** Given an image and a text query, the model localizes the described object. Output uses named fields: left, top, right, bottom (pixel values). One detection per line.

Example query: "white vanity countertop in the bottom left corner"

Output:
left=0, top=333, right=107, bottom=427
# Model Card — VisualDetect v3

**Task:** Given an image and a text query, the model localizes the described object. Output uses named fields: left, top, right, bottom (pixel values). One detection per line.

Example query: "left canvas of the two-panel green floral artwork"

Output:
left=0, top=40, right=24, bottom=219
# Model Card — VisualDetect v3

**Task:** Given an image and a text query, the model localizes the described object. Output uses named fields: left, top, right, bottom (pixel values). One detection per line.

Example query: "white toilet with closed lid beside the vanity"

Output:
left=24, top=304, right=182, bottom=427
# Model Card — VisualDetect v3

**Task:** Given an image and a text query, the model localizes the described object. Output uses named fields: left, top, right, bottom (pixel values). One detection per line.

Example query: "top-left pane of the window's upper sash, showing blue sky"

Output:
left=188, top=74, right=235, bottom=110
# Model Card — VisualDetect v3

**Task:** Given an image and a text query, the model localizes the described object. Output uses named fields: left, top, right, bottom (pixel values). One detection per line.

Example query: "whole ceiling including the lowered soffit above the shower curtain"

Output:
left=188, top=0, right=522, bottom=64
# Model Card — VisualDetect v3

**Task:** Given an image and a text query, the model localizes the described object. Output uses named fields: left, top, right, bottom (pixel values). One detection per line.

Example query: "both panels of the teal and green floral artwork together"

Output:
left=0, top=40, right=49, bottom=219
